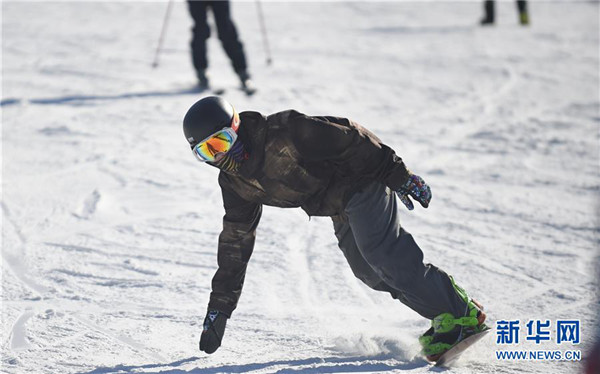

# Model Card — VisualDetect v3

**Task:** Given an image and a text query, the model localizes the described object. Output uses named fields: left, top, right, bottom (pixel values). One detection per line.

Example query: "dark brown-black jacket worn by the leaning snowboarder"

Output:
left=208, top=110, right=408, bottom=315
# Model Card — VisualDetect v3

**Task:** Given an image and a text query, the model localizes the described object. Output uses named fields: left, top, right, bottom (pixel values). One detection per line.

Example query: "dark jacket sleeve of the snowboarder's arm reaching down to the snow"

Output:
left=208, top=172, right=262, bottom=316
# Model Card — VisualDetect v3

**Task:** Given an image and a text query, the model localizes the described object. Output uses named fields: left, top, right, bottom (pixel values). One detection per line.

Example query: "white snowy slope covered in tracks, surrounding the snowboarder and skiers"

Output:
left=0, top=1, right=600, bottom=374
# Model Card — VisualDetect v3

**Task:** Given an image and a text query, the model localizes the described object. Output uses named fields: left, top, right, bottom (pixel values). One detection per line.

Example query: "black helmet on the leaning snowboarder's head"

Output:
left=183, top=96, right=237, bottom=147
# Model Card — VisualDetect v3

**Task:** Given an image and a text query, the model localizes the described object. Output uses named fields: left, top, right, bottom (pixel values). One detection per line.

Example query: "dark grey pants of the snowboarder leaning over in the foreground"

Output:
left=332, top=183, right=467, bottom=319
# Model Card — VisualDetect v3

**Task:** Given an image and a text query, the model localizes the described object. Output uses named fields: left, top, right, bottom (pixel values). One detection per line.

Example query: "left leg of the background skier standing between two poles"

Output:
left=188, top=0, right=210, bottom=90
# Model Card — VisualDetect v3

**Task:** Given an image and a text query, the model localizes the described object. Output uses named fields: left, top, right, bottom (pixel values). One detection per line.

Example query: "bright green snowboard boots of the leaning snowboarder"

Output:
left=419, top=277, right=489, bottom=362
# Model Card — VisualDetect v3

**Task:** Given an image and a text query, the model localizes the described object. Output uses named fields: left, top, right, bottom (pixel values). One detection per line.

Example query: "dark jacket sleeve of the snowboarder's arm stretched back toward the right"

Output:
left=289, top=111, right=409, bottom=191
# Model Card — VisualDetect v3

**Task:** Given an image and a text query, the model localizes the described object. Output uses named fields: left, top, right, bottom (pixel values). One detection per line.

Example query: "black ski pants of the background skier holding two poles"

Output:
left=188, top=0, right=247, bottom=78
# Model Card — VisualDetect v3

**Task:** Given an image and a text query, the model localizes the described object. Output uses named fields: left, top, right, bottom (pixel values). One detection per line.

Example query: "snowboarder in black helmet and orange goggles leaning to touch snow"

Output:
left=183, top=96, right=486, bottom=361
